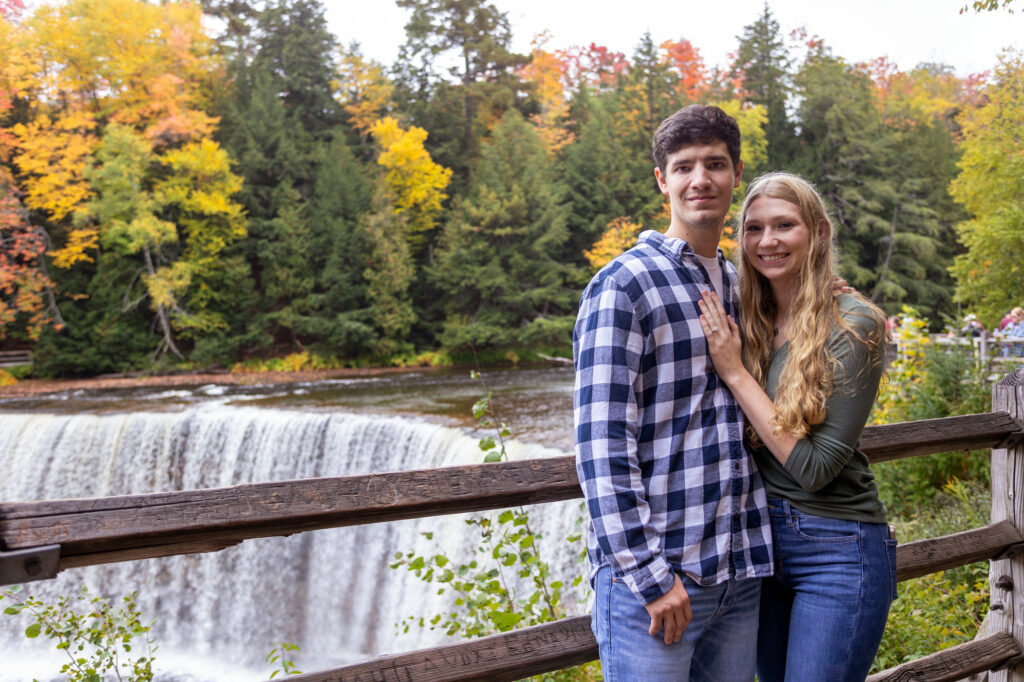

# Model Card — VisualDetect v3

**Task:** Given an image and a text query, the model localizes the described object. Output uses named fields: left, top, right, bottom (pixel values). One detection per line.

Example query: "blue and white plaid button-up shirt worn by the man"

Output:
left=572, top=231, right=772, bottom=604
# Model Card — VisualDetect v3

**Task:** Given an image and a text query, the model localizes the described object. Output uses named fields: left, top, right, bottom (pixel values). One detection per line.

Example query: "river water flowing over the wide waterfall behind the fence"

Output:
left=0, top=368, right=585, bottom=682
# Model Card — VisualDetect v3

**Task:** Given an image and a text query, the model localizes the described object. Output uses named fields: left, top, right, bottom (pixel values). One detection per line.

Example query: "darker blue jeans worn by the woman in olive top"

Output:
left=758, top=498, right=896, bottom=682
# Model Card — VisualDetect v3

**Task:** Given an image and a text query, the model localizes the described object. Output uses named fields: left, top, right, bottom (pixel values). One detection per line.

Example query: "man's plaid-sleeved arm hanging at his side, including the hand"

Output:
left=573, top=278, right=686, bottom=635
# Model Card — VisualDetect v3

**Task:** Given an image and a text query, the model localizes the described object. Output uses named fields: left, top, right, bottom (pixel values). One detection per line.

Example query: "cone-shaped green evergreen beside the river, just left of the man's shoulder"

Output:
left=433, top=112, right=582, bottom=348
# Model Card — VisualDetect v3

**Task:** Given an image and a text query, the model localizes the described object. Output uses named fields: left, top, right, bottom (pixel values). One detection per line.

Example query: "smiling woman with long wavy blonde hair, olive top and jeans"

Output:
left=699, top=173, right=896, bottom=682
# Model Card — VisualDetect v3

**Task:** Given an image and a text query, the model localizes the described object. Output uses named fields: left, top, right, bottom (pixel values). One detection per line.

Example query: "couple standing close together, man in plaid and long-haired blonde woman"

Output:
left=573, top=105, right=896, bottom=682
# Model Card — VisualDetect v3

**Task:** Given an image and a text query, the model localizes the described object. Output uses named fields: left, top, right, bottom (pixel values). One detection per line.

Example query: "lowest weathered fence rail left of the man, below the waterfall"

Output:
left=289, top=615, right=597, bottom=682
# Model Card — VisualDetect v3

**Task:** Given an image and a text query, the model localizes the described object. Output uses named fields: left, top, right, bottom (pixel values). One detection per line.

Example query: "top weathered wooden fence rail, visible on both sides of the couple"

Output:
left=0, top=413, right=1021, bottom=568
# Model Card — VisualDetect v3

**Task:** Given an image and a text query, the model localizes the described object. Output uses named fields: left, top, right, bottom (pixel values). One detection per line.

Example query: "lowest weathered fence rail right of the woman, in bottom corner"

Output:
left=866, top=632, right=1021, bottom=682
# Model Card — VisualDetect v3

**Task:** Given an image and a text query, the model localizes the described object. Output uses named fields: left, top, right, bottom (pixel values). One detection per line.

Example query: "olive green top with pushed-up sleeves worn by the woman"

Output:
left=754, top=294, right=886, bottom=523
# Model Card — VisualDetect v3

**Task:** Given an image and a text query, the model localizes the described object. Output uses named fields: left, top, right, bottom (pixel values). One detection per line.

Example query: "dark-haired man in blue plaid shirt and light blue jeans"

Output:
left=573, top=105, right=772, bottom=682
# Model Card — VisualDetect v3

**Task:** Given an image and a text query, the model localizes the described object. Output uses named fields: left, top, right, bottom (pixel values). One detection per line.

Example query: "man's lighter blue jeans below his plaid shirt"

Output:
left=591, top=566, right=761, bottom=682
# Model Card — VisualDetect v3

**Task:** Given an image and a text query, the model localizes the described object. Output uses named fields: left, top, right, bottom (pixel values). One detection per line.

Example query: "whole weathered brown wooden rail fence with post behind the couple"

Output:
left=6, top=369, right=1024, bottom=682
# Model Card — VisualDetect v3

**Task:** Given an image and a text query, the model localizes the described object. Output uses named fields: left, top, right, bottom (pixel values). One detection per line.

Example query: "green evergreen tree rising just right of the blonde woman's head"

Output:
left=798, top=53, right=949, bottom=315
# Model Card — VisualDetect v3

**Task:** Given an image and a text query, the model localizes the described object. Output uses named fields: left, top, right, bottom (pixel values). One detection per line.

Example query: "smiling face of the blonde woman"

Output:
left=742, top=197, right=811, bottom=285
